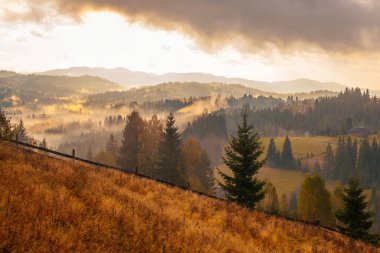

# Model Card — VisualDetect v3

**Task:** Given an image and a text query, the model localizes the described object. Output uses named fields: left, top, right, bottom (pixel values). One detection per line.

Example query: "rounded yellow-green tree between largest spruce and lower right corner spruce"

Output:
left=298, top=174, right=334, bottom=226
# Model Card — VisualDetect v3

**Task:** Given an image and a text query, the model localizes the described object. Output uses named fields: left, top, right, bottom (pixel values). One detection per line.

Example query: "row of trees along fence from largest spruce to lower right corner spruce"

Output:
left=219, top=108, right=380, bottom=244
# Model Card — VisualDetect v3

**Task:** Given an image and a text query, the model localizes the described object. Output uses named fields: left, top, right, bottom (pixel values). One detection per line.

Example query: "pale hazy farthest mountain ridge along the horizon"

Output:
left=38, top=67, right=346, bottom=93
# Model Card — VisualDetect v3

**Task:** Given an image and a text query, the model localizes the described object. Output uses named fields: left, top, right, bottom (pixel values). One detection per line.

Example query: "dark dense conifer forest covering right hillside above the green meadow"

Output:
left=186, top=88, right=380, bottom=136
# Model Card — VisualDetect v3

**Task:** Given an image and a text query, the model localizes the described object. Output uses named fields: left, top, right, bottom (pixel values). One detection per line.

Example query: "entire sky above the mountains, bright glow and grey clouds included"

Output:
left=0, top=0, right=380, bottom=89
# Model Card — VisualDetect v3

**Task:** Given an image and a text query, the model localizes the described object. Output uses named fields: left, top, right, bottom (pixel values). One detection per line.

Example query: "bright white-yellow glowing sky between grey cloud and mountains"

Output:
left=0, top=7, right=380, bottom=89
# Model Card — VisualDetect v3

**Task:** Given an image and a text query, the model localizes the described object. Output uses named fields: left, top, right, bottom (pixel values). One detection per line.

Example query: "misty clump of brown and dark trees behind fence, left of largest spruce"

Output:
left=94, top=110, right=213, bottom=192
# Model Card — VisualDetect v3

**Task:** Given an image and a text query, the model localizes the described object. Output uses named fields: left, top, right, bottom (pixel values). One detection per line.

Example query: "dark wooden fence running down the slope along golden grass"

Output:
left=0, top=137, right=341, bottom=233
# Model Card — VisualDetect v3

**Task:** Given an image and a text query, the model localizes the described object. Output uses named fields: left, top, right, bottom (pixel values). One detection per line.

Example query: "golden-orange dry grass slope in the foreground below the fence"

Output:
left=0, top=143, right=379, bottom=253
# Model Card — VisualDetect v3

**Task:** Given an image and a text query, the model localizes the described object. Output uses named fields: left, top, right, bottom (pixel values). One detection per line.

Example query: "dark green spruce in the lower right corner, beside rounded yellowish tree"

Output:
left=336, top=178, right=376, bottom=242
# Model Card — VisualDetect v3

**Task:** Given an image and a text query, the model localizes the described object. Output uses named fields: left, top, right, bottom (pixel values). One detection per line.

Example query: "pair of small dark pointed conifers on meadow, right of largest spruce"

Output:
left=266, top=136, right=301, bottom=170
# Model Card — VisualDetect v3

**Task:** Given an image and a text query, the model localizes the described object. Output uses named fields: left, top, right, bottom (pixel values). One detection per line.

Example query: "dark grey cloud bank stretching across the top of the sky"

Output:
left=2, top=0, right=380, bottom=53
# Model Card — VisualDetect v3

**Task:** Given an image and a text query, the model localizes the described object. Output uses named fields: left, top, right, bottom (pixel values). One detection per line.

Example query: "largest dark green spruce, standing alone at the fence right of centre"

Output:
left=219, top=109, right=265, bottom=208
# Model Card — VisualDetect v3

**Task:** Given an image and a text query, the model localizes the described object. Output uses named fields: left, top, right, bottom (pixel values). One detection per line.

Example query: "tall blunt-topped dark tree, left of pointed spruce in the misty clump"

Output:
left=117, top=111, right=145, bottom=171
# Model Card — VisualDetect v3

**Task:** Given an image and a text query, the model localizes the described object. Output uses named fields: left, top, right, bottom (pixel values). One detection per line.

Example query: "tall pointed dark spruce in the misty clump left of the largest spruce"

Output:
left=157, top=113, right=188, bottom=186
